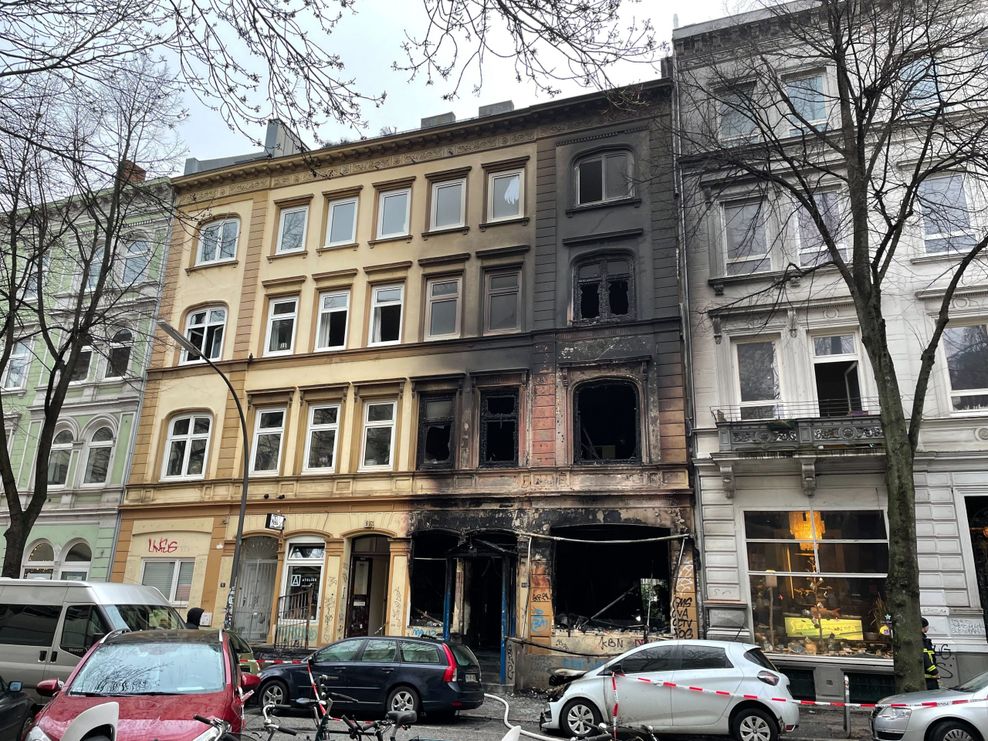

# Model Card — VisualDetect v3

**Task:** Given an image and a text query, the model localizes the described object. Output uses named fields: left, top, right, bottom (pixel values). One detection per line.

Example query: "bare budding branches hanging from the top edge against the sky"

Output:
left=0, top=0, right=656, bottom=143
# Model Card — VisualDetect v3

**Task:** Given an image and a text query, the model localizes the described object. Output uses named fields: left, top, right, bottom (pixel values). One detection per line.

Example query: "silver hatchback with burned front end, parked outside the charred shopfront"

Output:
left=540, top=641, right=799, bottom=741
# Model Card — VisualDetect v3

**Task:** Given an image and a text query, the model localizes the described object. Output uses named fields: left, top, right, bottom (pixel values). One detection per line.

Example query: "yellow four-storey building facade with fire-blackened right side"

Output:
left=114, top=78, right=698, bottom=686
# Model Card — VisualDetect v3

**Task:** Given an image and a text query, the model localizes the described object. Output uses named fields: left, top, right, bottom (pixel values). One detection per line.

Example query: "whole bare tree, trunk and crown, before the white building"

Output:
left=676, top=0, right=988, bottom=690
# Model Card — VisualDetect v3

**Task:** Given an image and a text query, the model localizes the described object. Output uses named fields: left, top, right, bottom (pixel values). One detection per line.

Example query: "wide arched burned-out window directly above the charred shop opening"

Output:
left=574, top=381, right=640, bottom=463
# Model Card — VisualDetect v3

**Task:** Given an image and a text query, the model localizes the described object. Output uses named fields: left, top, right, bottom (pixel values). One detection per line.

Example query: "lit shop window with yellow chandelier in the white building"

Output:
left=744, top=510, right=891, bottom=656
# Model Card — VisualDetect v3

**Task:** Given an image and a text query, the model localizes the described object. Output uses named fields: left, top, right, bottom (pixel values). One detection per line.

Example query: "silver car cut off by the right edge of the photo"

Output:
left=871, top=672, right=988, bottom=741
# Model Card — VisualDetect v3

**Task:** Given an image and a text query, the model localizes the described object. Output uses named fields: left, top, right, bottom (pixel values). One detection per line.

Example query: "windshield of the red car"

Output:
left=69, top=641, right=224, bottom=696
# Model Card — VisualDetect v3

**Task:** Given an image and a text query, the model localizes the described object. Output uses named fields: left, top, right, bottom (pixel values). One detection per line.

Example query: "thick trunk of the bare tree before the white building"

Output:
left=859, top=296, right=926, bottom=692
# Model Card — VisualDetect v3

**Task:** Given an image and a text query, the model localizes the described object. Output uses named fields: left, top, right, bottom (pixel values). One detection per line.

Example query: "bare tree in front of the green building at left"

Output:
left=0, top=62, right=177, bottom=577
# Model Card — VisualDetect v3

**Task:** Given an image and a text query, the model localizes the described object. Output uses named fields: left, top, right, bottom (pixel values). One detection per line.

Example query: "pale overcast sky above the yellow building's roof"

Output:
left=180, top=0, right=738, bottom=168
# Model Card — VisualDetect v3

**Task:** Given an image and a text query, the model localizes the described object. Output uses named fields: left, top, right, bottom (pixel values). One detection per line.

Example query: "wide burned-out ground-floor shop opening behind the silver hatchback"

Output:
left=552, top=525, right=670, bottom=633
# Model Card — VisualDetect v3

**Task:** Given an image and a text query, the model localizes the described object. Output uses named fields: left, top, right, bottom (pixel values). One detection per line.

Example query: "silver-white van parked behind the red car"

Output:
left=0, top=579, right=185, bottom=700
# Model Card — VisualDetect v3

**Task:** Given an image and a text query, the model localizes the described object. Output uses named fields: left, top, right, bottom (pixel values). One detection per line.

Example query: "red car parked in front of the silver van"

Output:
left=25, top=630, right=258, bottom=741
